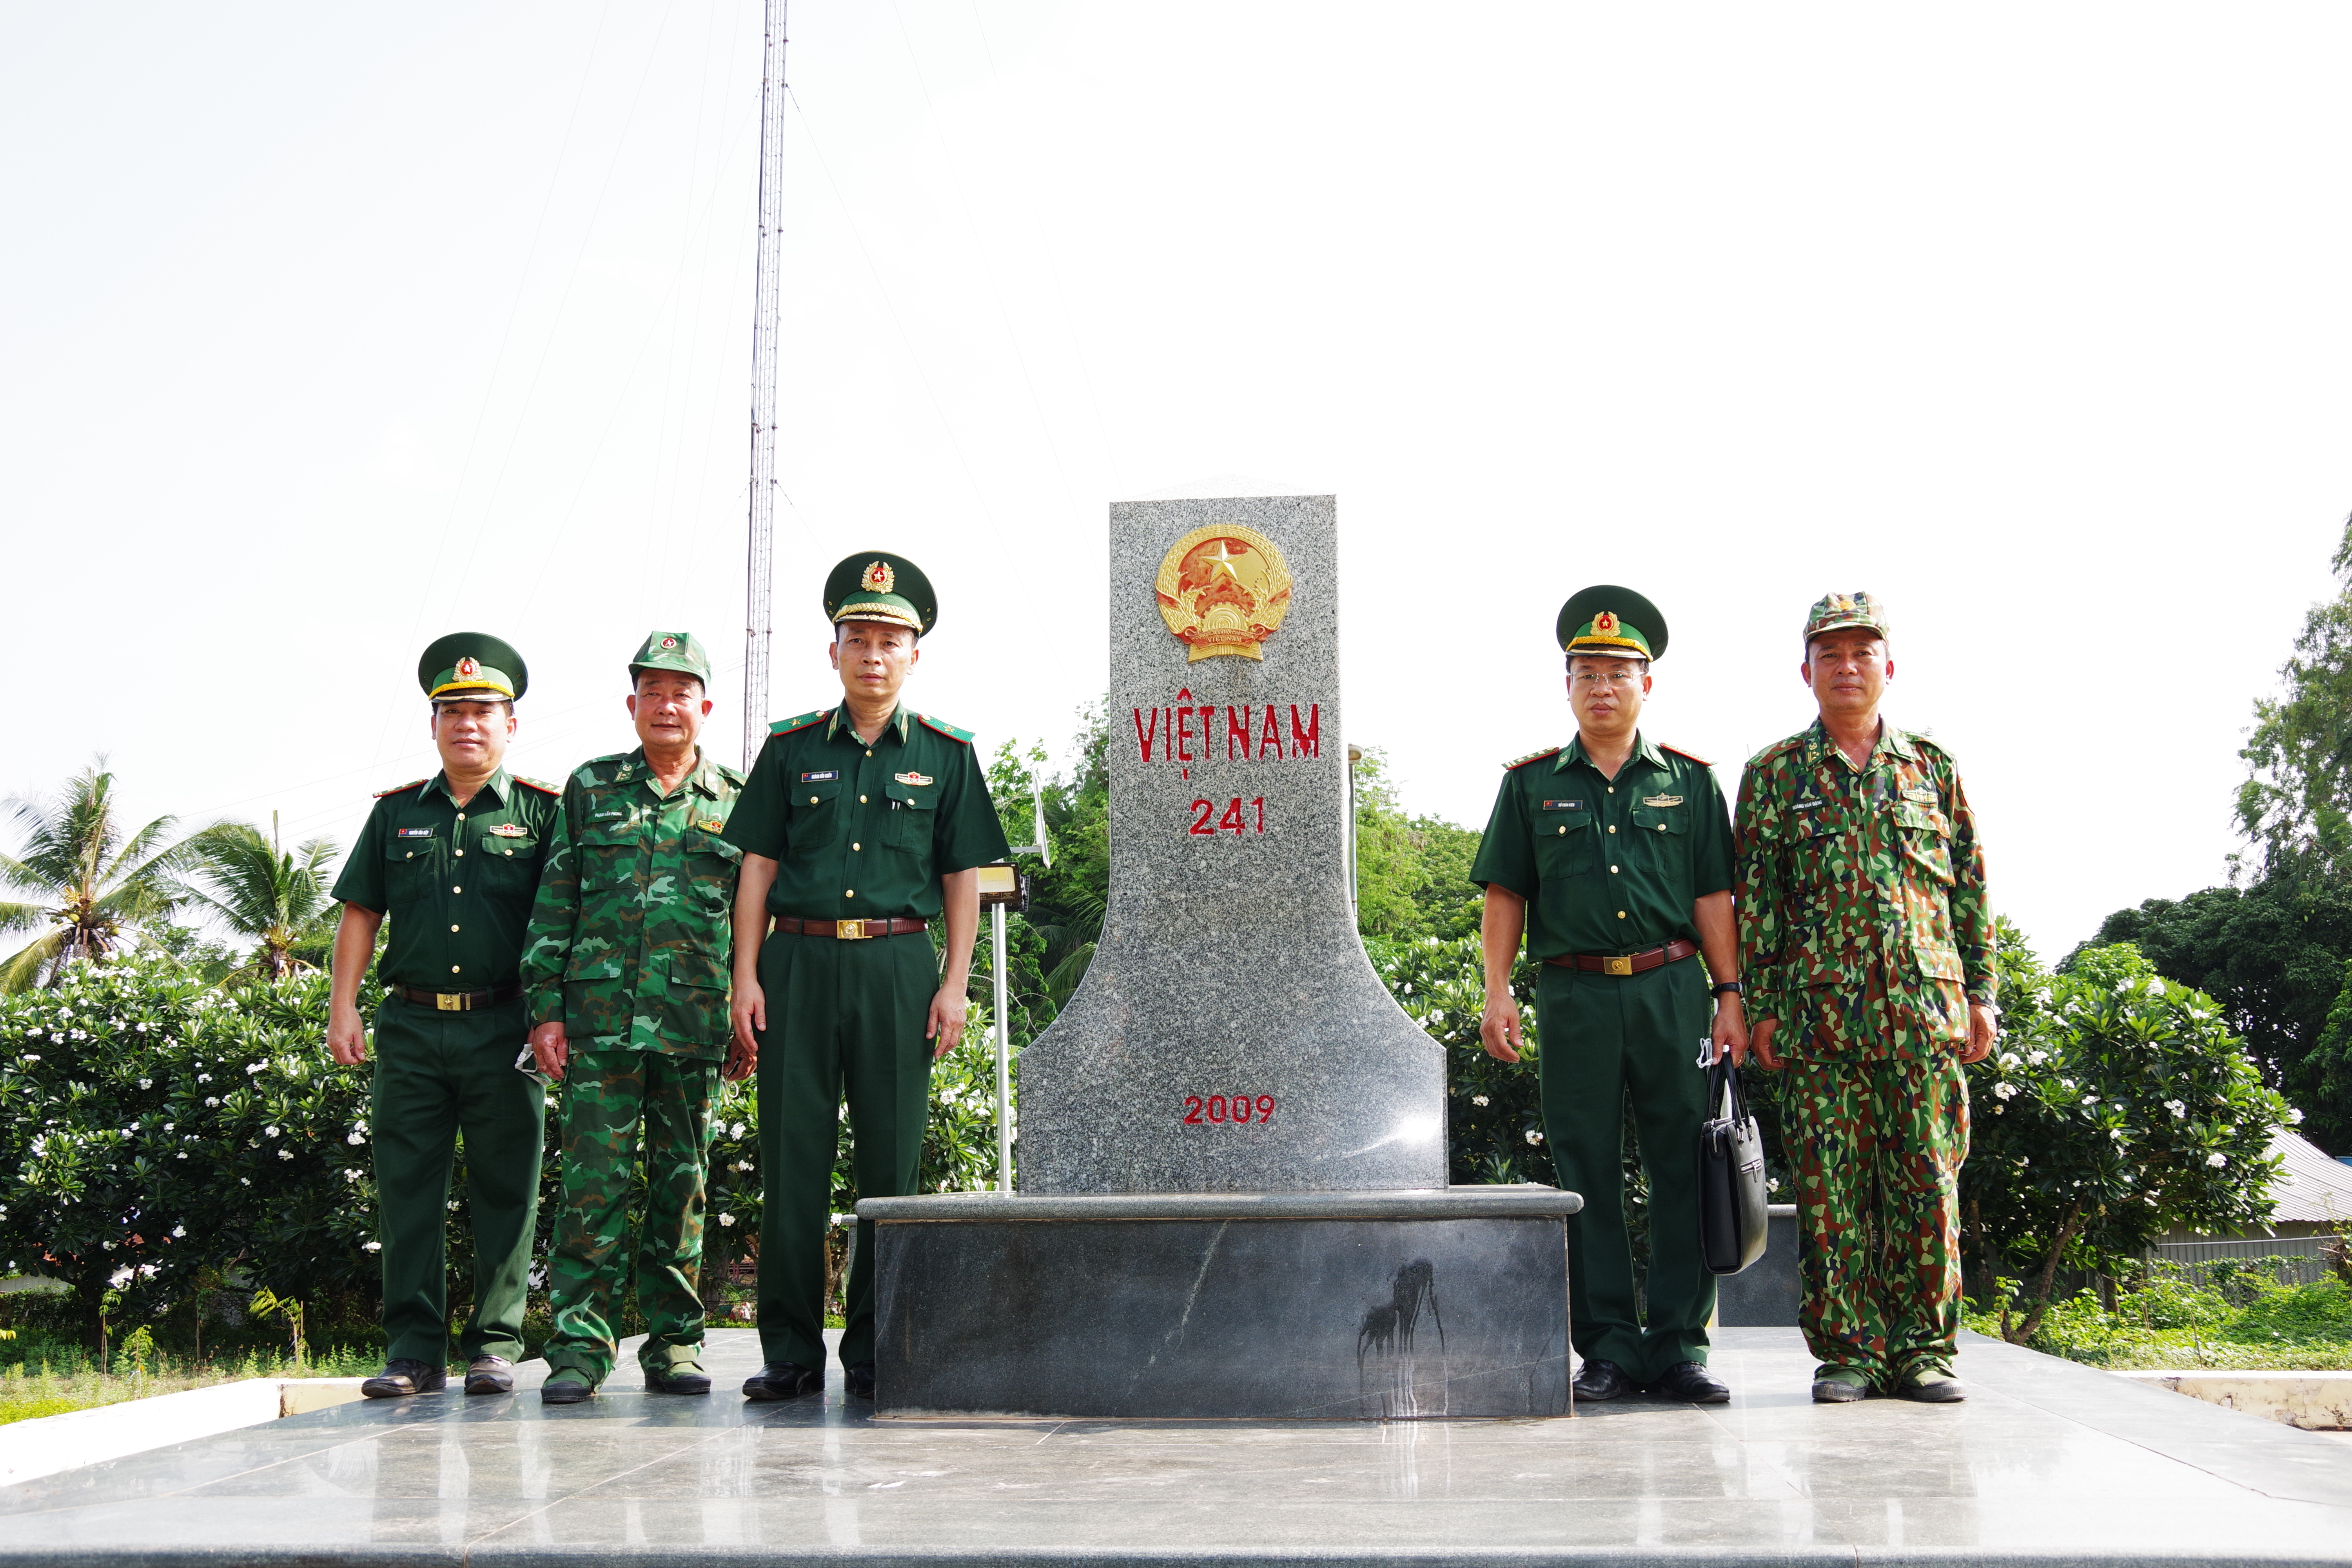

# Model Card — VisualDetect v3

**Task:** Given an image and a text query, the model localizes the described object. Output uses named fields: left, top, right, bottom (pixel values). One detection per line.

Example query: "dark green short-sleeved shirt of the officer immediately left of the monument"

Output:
left=724, top=705, right=1009, bottom=919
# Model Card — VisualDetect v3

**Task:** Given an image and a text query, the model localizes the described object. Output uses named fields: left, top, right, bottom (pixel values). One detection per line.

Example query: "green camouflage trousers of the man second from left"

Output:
left=546, top=1051, right=720, bottom=1382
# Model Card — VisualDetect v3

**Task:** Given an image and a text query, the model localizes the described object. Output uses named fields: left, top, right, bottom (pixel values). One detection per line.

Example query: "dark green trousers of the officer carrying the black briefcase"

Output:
left=1536, top=959, right=1715, bottom=1385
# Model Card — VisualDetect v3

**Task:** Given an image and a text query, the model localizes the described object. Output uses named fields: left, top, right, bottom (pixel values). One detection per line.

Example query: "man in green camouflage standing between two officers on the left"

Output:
left=522, top=632, right=748, bottom=1403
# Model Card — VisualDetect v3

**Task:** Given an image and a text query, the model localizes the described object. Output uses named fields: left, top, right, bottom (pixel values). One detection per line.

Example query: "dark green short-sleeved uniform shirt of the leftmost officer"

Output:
left=334, top=769, right=557, bottom=992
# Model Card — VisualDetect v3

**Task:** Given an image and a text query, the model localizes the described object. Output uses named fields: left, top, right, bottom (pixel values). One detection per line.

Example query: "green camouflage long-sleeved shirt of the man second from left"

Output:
left=522, top=745, right=743, bottom=1060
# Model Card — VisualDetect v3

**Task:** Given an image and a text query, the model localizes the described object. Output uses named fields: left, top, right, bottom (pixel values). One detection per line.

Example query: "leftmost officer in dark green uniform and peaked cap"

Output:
left=327, top=632, right=557, bottom=1399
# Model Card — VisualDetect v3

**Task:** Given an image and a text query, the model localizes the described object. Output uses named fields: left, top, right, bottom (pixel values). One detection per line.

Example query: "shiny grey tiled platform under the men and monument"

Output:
left=0, top=1328, right=2352, bottom=1568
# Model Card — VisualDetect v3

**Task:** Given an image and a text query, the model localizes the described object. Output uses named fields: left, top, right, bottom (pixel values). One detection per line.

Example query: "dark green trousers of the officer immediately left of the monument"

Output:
left=760, top=933, right=938, bottom=1368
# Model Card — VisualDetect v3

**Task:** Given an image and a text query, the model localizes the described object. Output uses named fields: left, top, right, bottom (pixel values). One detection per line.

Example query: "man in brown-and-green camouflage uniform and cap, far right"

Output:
left=1736, top=592, right=1999, bottom=1403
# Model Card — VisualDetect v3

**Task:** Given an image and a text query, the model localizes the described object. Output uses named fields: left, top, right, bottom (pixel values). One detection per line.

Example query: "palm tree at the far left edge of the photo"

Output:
left=0, top=757, right=191, bottom=992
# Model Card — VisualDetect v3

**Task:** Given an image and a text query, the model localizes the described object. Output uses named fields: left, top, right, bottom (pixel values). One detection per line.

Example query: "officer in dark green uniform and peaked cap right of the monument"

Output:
left=1470, top=585, right=1748, bottom=1403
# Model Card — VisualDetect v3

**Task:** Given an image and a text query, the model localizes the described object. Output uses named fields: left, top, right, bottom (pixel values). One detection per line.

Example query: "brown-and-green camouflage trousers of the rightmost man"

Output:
left=1780, top=1051, right=1969, bottom=1387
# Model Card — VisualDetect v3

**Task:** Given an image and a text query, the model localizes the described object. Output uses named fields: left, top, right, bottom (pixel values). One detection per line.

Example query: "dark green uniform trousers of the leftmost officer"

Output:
left=369, top=997, right=546, bottom=1366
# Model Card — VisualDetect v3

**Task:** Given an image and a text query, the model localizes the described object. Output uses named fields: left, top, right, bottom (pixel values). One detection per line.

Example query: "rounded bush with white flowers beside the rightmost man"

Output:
left=1959, top=933, right=2300, bottom=1342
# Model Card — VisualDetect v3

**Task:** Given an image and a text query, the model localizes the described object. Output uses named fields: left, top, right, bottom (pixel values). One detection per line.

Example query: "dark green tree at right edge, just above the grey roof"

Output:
left=2079, top=860, right=2352, bottom=1150
